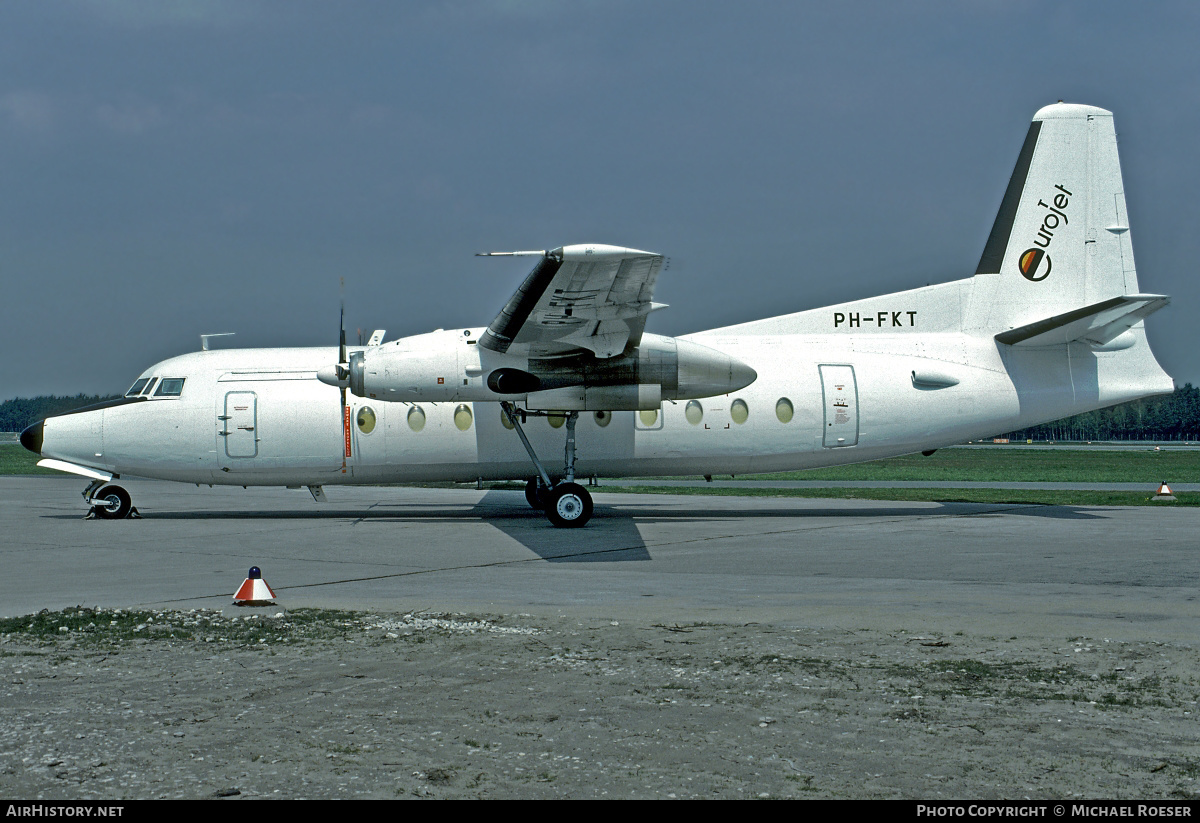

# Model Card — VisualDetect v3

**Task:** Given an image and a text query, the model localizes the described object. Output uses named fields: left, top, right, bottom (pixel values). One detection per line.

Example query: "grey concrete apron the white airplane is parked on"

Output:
left=0, top=476, right=1200, bottom=645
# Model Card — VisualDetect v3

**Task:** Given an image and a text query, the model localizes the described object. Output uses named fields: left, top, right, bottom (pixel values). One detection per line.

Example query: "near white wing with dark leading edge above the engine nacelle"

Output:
left=479, top=245, right=665, bottom=358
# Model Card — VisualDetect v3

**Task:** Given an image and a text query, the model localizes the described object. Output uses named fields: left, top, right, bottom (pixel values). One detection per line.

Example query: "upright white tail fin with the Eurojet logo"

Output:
left=967, top=103, right=1152, bottom=332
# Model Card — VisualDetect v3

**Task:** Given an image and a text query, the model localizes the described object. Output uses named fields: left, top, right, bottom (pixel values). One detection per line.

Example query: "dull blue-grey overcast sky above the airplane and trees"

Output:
left=0, top=0, right=1200, bottom=400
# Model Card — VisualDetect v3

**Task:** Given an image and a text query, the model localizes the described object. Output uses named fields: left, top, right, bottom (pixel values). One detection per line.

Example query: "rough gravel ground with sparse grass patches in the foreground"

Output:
left=0, top=607, right=1200, bottom=799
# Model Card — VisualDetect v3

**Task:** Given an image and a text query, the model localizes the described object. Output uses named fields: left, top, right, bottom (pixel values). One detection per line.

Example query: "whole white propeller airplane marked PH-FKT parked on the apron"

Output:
left=20, top=103, right=1174, bottom=527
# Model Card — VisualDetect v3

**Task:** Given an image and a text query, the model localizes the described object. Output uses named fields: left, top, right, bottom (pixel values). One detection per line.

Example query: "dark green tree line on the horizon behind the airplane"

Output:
left=0, top=383, right=1200, bottom=440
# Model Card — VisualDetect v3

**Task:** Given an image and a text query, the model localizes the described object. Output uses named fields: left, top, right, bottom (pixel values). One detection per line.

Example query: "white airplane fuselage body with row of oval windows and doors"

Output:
left=35, top=299, right=1170, bottom=486
